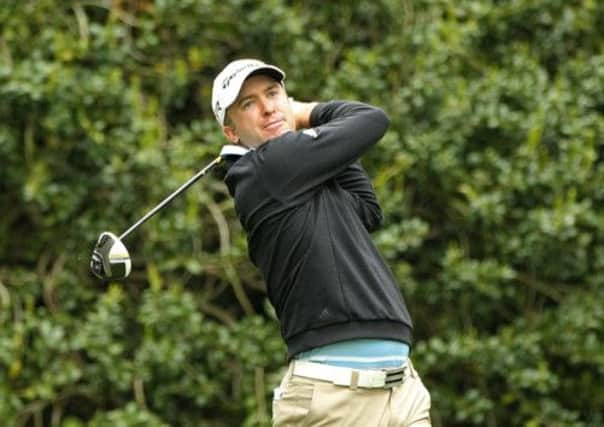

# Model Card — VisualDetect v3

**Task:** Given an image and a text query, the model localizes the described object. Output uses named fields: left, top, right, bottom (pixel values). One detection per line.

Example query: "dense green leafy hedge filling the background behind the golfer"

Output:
left=0, top=0, right=604, bottom=427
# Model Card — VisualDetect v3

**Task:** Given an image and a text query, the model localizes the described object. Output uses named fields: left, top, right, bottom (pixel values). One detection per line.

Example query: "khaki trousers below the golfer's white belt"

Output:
left=273, top=360, right=431, bottom=427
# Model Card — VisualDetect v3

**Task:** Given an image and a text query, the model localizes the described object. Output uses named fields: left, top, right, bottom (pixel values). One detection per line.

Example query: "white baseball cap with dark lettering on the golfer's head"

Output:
left=212, top=59, right=285, bottom=126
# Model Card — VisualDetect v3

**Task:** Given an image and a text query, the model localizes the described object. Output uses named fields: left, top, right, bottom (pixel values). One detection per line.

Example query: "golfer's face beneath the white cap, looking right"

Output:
left=223, top=74, right=296, bottom=148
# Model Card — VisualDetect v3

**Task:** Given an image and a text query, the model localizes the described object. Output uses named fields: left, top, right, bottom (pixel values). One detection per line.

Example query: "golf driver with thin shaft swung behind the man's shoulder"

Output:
left=90, top=145, right=248, bottom=280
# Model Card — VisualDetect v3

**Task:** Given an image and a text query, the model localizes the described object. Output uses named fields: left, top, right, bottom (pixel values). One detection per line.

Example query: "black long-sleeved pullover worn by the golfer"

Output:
left=225, top=101, right=412, bottom=357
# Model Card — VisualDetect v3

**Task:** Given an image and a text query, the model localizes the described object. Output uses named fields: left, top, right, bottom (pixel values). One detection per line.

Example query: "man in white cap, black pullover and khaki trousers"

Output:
left=212, top=59, right=430, bottom=427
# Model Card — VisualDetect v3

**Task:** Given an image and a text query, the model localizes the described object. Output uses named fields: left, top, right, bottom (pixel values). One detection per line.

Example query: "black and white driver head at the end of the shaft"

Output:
left=90, top=231, right=132, bottom=280
